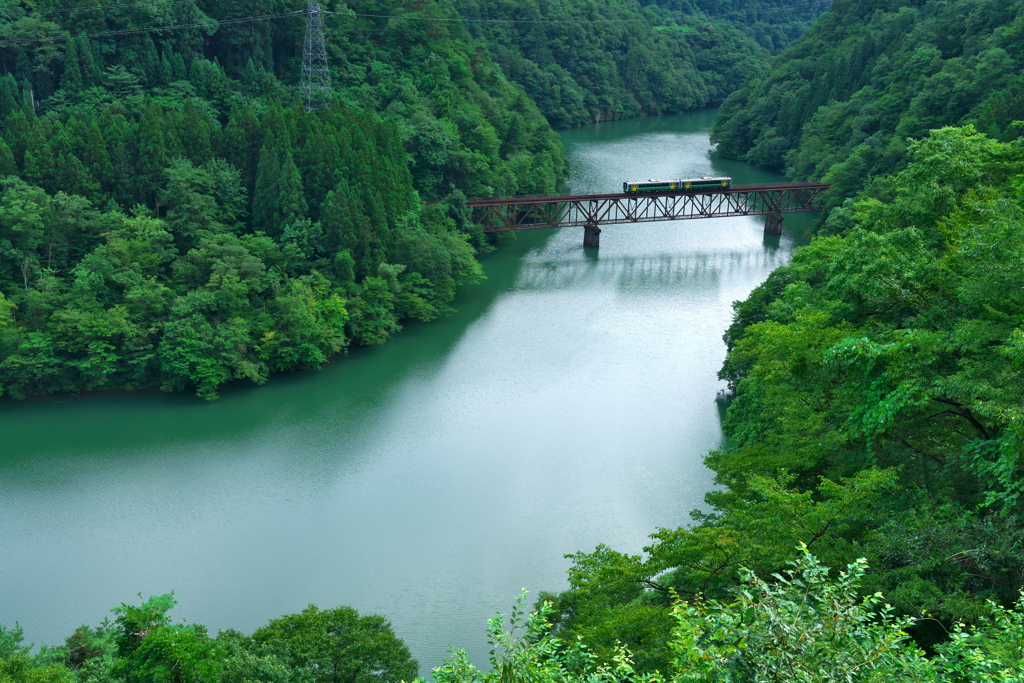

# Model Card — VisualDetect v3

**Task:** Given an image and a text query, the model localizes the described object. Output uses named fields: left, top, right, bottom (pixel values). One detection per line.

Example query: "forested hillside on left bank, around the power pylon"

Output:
left=0, top=0, right=565, bottom=397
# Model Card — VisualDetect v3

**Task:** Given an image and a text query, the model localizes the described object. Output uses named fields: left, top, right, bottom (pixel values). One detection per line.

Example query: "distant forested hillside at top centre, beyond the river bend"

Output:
left=455, top=0, right=828, bottom=128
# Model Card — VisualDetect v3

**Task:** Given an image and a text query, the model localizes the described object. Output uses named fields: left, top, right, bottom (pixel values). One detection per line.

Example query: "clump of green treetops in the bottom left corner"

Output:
left=0, top=593, right=418, bottom=683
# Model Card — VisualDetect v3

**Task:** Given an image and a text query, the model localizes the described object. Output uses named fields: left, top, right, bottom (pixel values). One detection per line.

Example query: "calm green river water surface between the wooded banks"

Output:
left=0, top=112, right=810, bottom=674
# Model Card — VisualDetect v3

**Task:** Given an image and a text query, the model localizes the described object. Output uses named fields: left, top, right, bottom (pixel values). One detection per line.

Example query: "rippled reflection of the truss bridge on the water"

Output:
left=516, top=250, right=788, bottom=291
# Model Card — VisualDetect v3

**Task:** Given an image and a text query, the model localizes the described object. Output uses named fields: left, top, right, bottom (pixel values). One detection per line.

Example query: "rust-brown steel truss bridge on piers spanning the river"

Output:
left=466, top=182, right=830, bottom=247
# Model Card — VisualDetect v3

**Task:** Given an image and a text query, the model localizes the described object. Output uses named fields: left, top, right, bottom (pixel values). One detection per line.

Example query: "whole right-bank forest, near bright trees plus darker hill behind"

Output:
left=528, top=0, right=1024, bottom=680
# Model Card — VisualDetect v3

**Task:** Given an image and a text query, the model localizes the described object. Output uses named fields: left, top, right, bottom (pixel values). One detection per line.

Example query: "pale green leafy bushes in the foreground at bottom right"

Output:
left=433, top=549, right=1024, bottom=683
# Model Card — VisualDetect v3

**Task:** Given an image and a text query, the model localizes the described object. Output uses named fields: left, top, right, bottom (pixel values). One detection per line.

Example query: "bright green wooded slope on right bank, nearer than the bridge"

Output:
left=536, top=127, right=1024, bottom=680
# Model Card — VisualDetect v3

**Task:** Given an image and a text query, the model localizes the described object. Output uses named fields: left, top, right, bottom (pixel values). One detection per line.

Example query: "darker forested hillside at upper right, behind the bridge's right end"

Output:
left=713, top=0, right=1024, bottom=203
